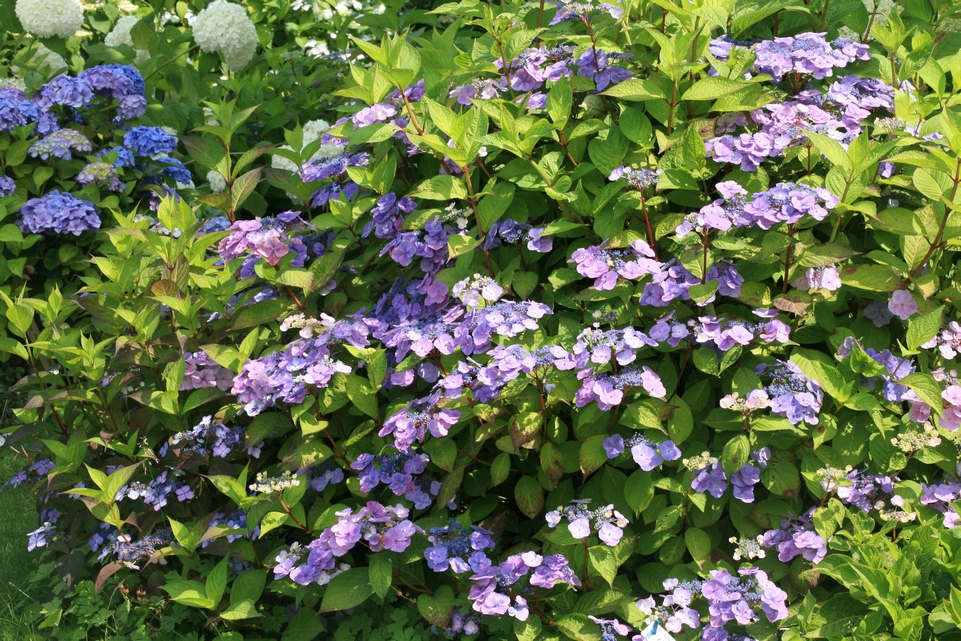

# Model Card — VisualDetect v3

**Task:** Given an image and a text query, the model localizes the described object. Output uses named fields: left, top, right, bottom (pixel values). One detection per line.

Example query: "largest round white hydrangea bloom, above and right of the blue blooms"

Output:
left=193, top=0, right=257, bottom=71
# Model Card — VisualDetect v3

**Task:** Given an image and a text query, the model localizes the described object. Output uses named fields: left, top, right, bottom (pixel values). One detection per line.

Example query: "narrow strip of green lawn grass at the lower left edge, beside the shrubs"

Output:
left=0, top=449, right=38, bottom=641
